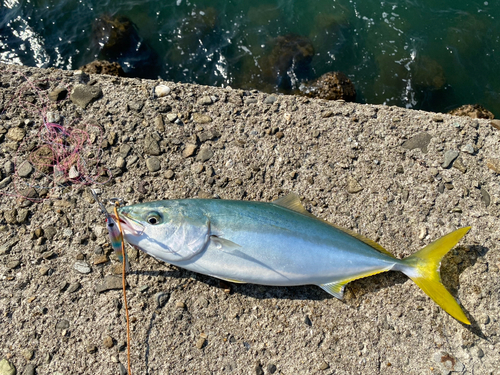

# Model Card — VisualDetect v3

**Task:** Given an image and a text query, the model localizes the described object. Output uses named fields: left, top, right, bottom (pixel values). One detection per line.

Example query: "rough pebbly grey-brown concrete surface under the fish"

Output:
left=0, top=65, right=500, bottom=375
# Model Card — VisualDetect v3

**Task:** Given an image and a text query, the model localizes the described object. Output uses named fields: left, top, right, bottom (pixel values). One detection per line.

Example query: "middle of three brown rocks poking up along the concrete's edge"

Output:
left=299, top=72, right=356, bottom=102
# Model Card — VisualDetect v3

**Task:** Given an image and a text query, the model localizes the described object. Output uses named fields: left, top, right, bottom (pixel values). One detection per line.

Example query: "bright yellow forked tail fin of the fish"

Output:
left=401, top=227, right=470, bottom=324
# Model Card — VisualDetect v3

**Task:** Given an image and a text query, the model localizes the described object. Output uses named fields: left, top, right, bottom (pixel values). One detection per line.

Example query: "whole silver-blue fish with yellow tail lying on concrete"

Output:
left=118, top=193, right=470, bottom=324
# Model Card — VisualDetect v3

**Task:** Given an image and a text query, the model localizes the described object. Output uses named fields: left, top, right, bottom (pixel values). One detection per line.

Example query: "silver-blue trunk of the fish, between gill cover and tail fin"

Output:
left=172, top=201, right=398, bottom=286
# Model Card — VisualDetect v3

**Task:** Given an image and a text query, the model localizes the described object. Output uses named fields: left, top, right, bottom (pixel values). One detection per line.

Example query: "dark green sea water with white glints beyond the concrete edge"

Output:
left=0, top=0, right=500, bottom=116
